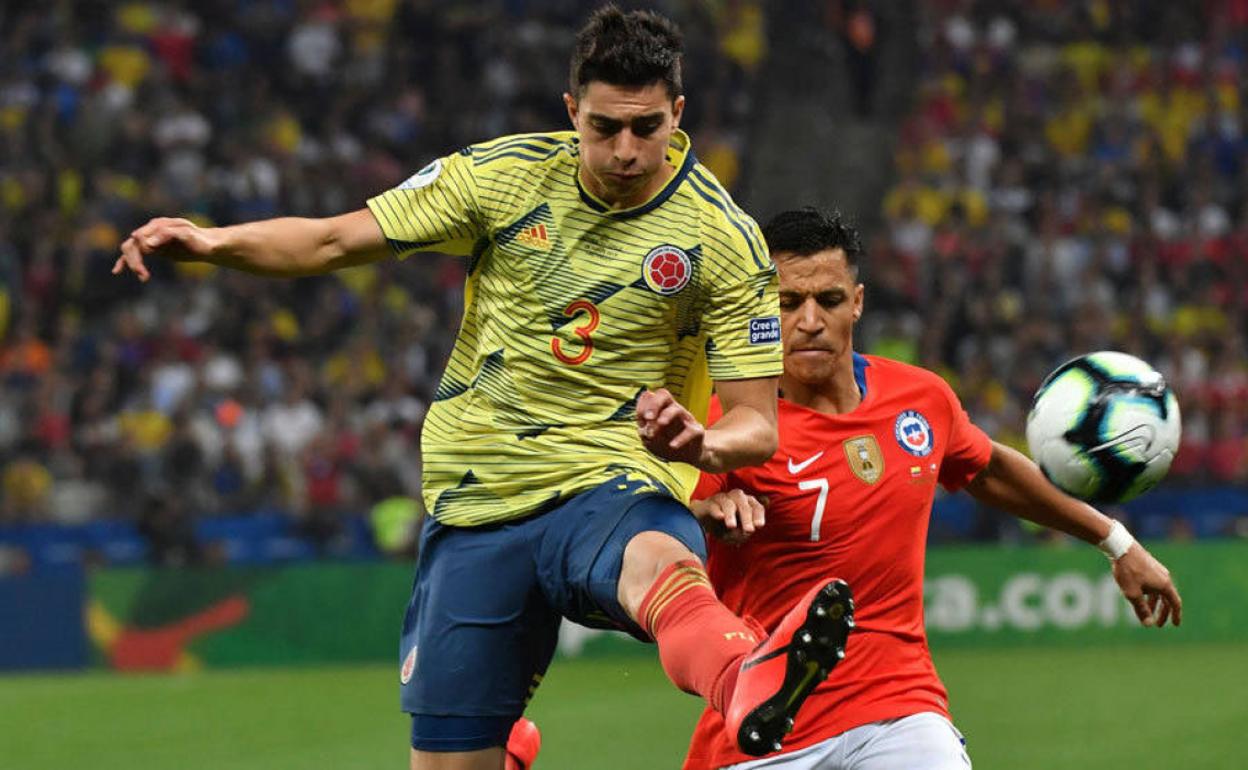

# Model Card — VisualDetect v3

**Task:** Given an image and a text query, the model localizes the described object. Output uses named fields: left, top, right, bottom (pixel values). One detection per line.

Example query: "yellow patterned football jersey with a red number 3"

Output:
left=368, top=131, right=781, bottom=525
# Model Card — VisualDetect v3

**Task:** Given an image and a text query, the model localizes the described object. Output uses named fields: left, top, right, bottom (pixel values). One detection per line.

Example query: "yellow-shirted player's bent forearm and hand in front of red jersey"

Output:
left=636, top=377, right=779, bottom=473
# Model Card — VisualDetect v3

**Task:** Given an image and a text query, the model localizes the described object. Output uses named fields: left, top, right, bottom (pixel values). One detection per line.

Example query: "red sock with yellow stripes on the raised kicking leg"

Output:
left=638, top=560, right=763, bottom=713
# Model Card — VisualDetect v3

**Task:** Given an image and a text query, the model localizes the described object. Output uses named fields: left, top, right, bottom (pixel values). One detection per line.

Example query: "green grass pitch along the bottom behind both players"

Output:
left=0, top=644, right=1248, bottom=770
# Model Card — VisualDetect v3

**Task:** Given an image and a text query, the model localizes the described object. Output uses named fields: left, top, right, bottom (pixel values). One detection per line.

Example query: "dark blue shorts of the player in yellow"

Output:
left=399, top=475, right=706, bottom=751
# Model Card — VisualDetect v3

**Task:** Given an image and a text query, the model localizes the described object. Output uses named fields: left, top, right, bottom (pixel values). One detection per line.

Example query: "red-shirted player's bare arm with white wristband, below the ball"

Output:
left=966, top=442, right=1183, bottom=626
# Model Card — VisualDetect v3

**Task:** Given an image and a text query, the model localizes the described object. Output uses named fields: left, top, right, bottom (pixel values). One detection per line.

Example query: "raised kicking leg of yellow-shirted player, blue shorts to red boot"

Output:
left=538, top=475, right=854, bottom=755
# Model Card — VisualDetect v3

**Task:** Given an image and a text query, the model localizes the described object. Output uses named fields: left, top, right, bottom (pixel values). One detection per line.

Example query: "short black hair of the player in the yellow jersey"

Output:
left=568, top=4, right=684, bottom=100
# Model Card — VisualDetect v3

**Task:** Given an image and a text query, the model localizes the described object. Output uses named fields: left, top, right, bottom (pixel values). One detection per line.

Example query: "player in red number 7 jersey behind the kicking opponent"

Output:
left=685, top=208, right=1181, bottom=770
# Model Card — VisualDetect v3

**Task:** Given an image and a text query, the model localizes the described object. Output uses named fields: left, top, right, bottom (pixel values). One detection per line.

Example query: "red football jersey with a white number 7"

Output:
left=685, top=354, right=992, bottom=770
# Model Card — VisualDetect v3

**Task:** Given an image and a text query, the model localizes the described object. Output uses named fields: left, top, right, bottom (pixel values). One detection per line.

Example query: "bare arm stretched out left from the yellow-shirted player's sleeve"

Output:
left=112, top=208, right=389, bottom=281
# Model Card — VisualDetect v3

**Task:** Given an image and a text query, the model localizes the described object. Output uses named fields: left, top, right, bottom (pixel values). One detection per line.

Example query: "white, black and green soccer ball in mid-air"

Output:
left=1027, top=351, right=1181, bottom=503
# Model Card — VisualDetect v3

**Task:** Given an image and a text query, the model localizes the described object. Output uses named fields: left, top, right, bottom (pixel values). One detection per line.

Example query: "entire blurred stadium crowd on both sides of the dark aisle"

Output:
left=0, top=0, right=1248, bottom=564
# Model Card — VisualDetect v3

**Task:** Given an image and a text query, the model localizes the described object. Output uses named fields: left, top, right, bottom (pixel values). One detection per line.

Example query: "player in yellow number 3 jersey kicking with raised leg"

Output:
left=114, top=5, right=852, bottom=770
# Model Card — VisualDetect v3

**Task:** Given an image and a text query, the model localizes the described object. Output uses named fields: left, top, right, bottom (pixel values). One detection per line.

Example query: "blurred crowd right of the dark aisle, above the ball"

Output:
left=866, top=0, right=1248, bottom=482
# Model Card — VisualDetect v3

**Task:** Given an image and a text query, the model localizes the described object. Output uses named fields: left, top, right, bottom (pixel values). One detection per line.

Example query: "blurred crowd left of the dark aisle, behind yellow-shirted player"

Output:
left=0, top=0, right=765, bottom=555
